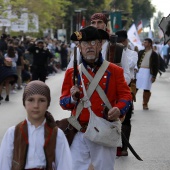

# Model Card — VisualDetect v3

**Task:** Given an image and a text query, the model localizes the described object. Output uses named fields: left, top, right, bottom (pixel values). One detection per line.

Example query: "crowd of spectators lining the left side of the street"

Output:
left=0, top=34, right=71, bottom=102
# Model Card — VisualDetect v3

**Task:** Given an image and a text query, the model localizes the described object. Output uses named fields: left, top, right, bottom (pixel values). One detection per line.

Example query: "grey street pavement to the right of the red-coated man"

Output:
left=115, top=66, right=170, bottom=170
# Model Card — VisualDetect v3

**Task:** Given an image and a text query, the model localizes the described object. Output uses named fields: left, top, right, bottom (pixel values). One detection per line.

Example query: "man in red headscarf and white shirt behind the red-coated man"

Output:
left=67, top=13, right=131, bottom=84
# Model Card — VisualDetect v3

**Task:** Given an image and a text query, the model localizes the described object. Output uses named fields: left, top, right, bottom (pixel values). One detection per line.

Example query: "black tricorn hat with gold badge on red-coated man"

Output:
left=70, top=26, right=109, bottom=41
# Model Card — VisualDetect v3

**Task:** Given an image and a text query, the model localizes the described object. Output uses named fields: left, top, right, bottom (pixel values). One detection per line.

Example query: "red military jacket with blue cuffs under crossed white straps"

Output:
left=60, top=59, right=132, bottom=123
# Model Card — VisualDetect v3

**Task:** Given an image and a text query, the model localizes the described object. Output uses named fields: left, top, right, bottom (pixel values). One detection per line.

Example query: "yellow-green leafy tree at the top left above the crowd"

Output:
left=1, top=0, right=71, bottom=29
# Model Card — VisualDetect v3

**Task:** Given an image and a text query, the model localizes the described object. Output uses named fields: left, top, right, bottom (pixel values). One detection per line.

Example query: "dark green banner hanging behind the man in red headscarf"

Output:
left=110, top=11, right=122, bottom=32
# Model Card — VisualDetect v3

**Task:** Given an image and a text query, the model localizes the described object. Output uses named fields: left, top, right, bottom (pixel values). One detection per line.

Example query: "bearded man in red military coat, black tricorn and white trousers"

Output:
left=60, top=26, right=132, bottom=170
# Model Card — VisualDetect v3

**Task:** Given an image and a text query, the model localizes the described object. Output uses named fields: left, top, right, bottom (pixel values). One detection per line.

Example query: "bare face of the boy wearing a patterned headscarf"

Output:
left=25, top=94, right=48, bottom=123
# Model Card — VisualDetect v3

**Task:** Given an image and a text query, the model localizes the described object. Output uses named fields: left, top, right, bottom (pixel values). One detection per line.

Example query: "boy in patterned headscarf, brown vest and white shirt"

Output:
left=0, top=80, right=72, bottom=170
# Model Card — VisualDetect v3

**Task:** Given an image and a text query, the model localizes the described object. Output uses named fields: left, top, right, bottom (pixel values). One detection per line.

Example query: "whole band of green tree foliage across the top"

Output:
left=0, top=0, right=155, bottom=39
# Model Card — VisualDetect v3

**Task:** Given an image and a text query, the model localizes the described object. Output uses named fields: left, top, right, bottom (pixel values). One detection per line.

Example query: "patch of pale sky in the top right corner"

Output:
left=151, top=0, right=170, bottom=17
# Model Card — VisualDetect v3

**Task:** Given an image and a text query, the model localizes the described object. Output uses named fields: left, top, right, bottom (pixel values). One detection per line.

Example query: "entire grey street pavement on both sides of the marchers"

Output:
left=0, top=66, right=170, bottom=170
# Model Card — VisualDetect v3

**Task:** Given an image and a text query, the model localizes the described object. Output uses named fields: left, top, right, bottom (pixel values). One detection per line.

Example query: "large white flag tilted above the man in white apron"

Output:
left=127, top=24, right=143, bottom=50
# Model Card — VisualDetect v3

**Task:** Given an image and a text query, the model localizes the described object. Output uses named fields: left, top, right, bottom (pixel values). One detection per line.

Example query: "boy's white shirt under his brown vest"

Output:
left=0, top=119, right=72, bottom=170
